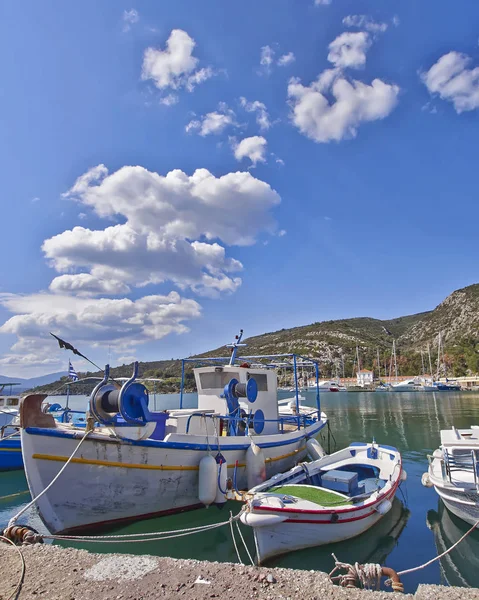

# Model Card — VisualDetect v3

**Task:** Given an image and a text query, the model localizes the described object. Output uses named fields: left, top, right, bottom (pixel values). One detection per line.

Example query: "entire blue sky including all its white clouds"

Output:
left=0, top=0, right=479, bottom=376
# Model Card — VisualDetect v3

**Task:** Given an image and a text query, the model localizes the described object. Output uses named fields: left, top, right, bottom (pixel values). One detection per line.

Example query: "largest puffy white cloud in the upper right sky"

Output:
left=288, top=69, right=399, bottom=143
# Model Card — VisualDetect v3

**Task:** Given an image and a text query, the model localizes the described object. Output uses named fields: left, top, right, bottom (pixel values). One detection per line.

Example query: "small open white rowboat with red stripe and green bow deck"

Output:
left=241, top=440, right=406, bottom=564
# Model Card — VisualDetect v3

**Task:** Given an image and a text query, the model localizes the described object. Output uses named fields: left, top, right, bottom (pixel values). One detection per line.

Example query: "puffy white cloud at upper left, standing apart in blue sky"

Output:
left=141, top=29, right=214, bottom=99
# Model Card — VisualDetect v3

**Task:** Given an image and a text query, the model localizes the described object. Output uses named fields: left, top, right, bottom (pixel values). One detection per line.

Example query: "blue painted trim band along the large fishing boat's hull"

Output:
left=25, top=420, right=327, bottom=451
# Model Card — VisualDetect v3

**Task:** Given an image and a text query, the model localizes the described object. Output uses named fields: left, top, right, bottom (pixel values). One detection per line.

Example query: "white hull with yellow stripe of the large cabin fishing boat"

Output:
left=21, top=418, right=327, bottom=532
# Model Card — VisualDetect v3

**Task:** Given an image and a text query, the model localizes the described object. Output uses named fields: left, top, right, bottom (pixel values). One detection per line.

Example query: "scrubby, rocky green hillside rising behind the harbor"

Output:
left=28, top=284, right=479, bottom=392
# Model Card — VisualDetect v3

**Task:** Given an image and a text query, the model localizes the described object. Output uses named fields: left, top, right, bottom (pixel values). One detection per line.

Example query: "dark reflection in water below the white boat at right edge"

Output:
left=427, top=500, right=479, bottom=587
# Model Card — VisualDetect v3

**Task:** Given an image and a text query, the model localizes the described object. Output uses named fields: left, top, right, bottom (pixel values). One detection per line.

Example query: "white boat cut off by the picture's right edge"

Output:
left=422, top=425, right=479, bottom=525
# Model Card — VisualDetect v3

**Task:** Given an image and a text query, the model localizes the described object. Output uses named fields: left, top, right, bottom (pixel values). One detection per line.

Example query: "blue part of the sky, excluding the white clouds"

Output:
left=0, top=0, right=479, bottom=376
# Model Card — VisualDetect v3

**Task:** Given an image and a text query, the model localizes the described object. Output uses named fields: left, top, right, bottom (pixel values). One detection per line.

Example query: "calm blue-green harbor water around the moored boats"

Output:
left=0, top=392, right=479, bottom=592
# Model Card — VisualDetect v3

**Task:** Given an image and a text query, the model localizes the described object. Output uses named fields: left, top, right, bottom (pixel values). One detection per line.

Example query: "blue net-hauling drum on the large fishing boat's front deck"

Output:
left=90, top=362, right=168, bottom=439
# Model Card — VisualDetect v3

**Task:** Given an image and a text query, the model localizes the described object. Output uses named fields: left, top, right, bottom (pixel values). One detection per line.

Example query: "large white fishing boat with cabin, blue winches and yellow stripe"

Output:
left=20, top=332, right=327, bottom=532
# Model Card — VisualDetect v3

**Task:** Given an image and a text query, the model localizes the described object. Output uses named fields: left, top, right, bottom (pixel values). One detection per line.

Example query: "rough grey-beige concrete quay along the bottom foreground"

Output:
left=0, top=544, right=479, bottom=600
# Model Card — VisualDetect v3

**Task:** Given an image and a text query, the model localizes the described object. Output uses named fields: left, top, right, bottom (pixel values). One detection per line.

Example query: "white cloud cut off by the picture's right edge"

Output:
left=421, top=51, right=479, bottom=114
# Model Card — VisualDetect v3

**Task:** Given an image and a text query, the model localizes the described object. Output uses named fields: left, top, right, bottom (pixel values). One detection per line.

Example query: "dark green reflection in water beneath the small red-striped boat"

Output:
left=267, top=498, right=410, bottom=572
